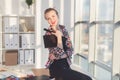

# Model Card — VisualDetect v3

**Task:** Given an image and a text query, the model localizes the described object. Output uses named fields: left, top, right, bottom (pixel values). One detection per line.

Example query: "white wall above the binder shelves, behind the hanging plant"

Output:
left=0, top=0, right=34, bottom=16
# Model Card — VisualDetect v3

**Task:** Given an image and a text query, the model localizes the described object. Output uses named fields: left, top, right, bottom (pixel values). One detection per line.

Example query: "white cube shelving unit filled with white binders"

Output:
left=2, top=16, right=35, bottom=64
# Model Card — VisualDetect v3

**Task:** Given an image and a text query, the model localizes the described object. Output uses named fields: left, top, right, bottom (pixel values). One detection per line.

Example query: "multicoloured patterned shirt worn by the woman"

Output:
left=45, top=25, right=73, bottom=68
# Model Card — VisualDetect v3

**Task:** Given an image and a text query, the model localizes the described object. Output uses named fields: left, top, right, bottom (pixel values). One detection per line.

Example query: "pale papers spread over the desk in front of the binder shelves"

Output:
left=0, top=65, right=34, bottom=78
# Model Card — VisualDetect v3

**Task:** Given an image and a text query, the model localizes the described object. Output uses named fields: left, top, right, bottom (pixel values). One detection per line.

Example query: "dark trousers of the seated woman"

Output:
left=49, top=59, right=92, bottom=80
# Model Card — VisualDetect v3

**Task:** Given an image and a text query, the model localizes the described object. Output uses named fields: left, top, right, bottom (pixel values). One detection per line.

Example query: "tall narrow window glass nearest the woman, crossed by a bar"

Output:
left=75, top=0, right=90, bottom=56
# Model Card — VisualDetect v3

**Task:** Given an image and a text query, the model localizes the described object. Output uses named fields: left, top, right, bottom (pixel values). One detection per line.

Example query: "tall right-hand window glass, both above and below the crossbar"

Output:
left=95, top=0, right=114, bottom=66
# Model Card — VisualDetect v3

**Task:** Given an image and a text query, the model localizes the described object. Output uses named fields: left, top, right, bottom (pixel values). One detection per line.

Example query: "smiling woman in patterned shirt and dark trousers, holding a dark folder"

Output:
left=44, top=8, right=91, bottom=80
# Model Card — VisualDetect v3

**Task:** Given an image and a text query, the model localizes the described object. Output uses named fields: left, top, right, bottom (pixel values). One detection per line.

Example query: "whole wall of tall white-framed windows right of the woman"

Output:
left=73, top=0, right=120, bottom=80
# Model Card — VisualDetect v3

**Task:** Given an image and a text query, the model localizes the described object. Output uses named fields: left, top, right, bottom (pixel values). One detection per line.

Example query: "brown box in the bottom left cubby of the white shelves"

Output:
left=5, top=51, right=18, bottom=66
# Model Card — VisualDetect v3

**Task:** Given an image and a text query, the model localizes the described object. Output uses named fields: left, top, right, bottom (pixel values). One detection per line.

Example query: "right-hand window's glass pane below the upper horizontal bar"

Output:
left=96, top=24, right=113, bottom=66
